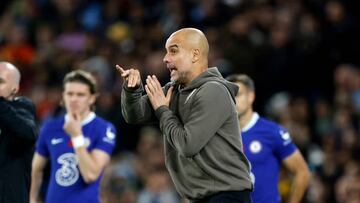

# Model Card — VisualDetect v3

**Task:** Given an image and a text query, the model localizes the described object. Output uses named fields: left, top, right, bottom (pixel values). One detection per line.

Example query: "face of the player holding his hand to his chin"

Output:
left=63, top=82, right=95, bottom=115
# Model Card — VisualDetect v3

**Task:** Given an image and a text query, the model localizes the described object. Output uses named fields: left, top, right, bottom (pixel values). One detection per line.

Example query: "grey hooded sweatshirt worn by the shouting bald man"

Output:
left=121, top=67, right=253, bottom=201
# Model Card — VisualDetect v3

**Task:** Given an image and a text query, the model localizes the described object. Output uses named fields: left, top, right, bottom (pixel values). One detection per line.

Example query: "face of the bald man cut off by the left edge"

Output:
left=0, top=67, right=16, bottom=99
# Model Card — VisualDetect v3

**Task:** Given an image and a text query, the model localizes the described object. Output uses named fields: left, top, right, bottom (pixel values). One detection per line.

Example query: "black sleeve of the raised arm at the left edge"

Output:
left=0, top=97, right=37, bottom=140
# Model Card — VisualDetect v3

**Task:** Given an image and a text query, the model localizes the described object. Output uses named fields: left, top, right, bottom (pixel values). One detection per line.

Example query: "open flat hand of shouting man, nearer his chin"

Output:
left=145, top=75, right=173, bottom=110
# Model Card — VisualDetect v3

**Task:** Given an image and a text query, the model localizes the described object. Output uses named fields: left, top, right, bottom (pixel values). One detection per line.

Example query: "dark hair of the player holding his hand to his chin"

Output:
left=63, top=70, right=97, bottom=94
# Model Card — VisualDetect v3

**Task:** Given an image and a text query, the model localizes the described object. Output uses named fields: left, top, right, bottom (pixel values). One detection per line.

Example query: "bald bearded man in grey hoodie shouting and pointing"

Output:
left=116, top=28, right=253, bottom=203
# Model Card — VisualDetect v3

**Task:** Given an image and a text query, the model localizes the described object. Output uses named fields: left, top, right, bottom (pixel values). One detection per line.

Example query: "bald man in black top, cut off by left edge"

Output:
left=0, top=62, right=37, bottom=203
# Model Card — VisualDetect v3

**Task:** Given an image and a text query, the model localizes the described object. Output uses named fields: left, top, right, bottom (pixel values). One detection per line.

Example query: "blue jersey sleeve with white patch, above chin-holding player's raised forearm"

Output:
left=94, top=122, right=116, bottom=156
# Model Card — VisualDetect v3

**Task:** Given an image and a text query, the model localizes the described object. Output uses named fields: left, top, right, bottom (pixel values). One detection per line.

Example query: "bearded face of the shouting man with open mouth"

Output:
left=163, top=33, right=193, bottom=84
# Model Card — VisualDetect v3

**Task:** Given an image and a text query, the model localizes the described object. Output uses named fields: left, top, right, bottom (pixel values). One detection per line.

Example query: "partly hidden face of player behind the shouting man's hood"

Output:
left=236, top=82, right=255, bottom=118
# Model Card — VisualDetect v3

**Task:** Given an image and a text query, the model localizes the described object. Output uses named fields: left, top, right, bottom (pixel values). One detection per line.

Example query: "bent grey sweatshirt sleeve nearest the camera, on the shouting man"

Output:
left=156, top=83, right=234, bottom=157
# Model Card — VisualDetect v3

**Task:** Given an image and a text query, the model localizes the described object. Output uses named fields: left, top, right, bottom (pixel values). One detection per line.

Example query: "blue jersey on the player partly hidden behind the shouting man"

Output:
left=242, top=113, right=297, bottom=203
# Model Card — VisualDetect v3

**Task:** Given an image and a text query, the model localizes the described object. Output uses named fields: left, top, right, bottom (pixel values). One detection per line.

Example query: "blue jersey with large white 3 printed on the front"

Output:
left=36, top=113, right=116, bottom=203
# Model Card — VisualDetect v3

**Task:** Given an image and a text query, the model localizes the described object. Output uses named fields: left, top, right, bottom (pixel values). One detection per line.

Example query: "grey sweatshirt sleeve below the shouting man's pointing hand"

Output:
left=121, top=84, right=154, bottom=124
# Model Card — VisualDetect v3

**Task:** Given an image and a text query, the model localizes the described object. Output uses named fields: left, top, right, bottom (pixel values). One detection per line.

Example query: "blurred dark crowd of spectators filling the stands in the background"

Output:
left=0, top=0, right=360, bottom=203
